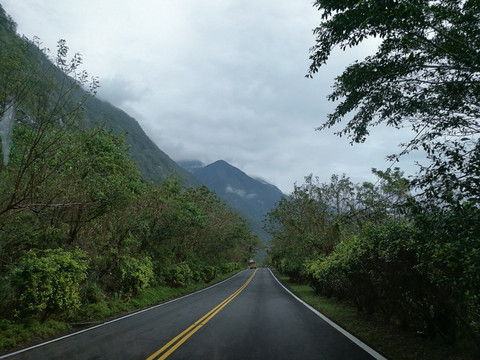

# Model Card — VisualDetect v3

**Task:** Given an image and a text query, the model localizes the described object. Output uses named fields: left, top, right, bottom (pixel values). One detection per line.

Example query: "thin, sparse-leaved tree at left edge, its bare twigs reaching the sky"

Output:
left=0, top=40, right=98, bottom=216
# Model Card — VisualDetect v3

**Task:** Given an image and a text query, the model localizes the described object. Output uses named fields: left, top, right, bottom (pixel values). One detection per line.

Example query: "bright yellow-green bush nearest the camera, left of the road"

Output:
left=11, top=249, right=88, bottom=320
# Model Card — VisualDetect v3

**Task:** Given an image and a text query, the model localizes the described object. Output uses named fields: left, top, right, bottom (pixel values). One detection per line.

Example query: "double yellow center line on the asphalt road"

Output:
left=147, top=269, right=258, bottom=360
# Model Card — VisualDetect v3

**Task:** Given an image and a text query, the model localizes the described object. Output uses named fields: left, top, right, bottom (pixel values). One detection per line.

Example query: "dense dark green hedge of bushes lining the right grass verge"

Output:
left=304, top=221, right=480, bottom=341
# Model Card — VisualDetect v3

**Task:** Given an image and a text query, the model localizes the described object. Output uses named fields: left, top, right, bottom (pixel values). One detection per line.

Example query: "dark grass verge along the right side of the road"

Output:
left=275, top=273, right=478, bottom=360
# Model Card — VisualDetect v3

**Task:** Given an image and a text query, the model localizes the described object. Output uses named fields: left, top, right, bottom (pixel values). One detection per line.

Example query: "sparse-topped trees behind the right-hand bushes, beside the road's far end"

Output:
left=265, top=172, right=409, bottom=280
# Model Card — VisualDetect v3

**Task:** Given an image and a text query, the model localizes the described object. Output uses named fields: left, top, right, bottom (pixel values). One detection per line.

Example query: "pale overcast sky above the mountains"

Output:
left=0, top=0, right=415, bottom=193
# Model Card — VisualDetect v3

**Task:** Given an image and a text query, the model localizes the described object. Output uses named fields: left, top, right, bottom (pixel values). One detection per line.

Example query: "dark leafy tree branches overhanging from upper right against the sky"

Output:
left=307, top=0, right=480, bottom=205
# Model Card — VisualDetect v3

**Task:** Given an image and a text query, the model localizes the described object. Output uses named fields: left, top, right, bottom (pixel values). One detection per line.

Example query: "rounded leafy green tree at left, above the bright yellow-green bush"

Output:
left=0, top=125, right=142, bottom=264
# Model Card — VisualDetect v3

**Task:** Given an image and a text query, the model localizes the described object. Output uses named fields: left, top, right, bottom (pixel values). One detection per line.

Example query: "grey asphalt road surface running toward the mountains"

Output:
left=0, top=268, right=383, bottom=360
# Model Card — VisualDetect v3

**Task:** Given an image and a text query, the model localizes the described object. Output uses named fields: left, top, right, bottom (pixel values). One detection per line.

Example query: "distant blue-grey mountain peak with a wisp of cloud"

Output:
left=179, top=160, right=285, bottom=243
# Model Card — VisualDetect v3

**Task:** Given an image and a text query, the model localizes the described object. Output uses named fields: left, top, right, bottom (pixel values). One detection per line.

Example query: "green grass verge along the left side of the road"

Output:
left=0, top=271, right=238, bottom=355
